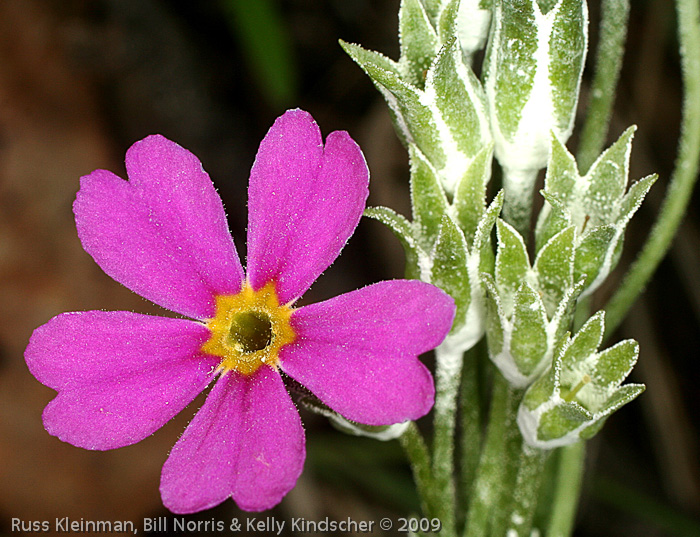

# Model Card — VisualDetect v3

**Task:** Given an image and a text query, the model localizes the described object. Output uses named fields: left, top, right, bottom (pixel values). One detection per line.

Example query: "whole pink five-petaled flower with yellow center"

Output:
left=25, top=110, right=454, bottom=513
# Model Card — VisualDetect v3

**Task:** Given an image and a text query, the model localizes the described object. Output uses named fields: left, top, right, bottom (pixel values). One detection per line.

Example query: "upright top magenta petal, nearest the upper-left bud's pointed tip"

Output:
left=248, top=110, right=369, bottom=303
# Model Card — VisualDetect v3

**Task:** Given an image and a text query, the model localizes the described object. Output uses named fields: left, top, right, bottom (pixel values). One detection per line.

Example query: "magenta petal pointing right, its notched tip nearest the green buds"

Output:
left=280, top=280, right=455, bottom=425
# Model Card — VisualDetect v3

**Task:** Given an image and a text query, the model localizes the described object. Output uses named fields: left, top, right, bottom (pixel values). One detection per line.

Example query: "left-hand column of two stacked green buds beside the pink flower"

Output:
left=342, top=0, right=503, bottom=351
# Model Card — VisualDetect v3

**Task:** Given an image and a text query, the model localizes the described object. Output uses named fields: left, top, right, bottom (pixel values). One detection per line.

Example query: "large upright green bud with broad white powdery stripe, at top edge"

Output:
left=484, top=0, right=588, bottom=227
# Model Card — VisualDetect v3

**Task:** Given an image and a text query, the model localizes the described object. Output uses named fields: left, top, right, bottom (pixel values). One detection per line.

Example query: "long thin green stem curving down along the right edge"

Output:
left=605, top=0, right=700, bottom=335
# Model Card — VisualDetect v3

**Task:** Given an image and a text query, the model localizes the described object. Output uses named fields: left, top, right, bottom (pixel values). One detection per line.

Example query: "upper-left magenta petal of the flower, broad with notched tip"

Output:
left=73, top=136, right=243, bottom=319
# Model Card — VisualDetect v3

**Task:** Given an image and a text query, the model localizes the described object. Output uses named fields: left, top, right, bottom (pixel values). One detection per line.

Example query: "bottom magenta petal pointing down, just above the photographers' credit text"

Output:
left=160, top=367, right=305, bottom=513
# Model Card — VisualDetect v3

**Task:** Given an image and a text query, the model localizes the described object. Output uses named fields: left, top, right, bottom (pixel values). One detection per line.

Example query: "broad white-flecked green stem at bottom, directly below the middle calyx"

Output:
left=464, top=373, right=522, bottom=537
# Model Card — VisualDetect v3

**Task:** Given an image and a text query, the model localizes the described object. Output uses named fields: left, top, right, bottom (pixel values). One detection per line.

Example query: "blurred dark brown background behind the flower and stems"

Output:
left=0, top=0, right=700, bottom=537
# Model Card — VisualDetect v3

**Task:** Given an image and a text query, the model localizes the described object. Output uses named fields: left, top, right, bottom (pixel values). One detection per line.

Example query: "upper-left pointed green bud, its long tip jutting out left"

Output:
left=342, top=0, right=491, bottom=195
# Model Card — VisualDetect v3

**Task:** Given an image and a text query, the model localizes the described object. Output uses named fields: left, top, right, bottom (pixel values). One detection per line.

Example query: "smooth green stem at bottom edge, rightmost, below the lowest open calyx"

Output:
left=545, top=442, right=586, bottom=537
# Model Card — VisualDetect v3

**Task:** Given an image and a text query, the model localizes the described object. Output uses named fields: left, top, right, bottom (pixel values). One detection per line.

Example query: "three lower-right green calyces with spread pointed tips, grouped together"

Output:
left=482, top=128, right=656, bottom=438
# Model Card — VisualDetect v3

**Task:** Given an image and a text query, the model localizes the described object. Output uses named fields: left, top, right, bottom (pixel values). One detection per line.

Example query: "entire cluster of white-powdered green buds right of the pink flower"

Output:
left=341, top=0, right=655, bottom=448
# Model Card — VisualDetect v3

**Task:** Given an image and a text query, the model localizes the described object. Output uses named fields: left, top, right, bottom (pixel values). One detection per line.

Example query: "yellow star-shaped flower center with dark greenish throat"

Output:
left=202, top=282, right=296, bottom=375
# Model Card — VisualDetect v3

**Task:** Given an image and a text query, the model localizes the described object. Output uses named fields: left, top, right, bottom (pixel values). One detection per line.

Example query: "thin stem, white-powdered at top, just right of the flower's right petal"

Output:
left=433, top=338, right=462, bottom=535
